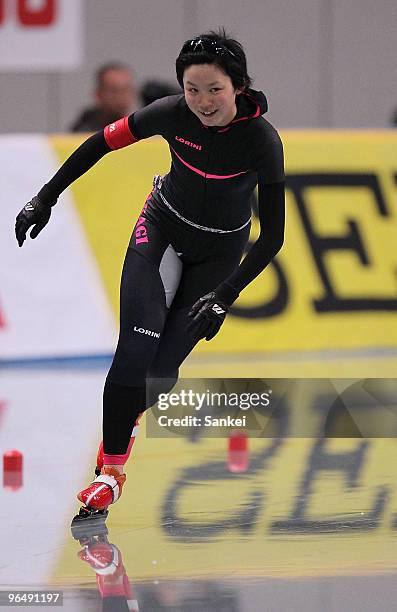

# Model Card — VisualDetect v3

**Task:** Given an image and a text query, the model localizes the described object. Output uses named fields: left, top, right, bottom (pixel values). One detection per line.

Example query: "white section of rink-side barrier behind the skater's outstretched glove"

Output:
left=0, top=136, right=116, bottom=360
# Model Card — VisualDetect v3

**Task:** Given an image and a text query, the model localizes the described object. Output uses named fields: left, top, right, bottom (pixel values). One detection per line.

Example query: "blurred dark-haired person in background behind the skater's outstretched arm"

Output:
left=70, top=62, right=137, bottom=132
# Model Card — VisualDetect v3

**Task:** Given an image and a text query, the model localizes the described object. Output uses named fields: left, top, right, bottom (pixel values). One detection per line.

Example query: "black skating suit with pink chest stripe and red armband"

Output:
left=39, top=90, right=284, bottom=455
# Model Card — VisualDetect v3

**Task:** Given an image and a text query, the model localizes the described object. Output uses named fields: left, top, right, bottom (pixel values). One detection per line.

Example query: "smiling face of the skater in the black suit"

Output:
left=183, top=64, right=241, bottom=127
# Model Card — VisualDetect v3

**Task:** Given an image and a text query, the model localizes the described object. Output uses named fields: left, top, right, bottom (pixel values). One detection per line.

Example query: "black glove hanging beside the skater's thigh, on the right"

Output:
left=188, top=291, right=229, bottom=341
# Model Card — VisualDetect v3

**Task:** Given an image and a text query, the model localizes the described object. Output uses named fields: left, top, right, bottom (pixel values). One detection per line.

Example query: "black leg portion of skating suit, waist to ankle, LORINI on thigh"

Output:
left=103, top=201, right=249, bottom=455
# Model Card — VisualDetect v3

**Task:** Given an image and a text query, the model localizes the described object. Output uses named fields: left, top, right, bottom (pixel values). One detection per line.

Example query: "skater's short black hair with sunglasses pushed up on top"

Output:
left=176, top=28, right=252, bottom=89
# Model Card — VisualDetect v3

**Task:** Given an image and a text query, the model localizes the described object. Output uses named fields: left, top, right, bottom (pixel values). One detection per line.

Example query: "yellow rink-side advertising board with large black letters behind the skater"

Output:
left=52, top=131, right=397, bottom=354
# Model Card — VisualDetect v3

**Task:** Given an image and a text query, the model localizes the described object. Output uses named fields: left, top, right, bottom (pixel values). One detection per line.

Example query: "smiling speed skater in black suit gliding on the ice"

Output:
left=15, top=29, right=285, bottom=517
